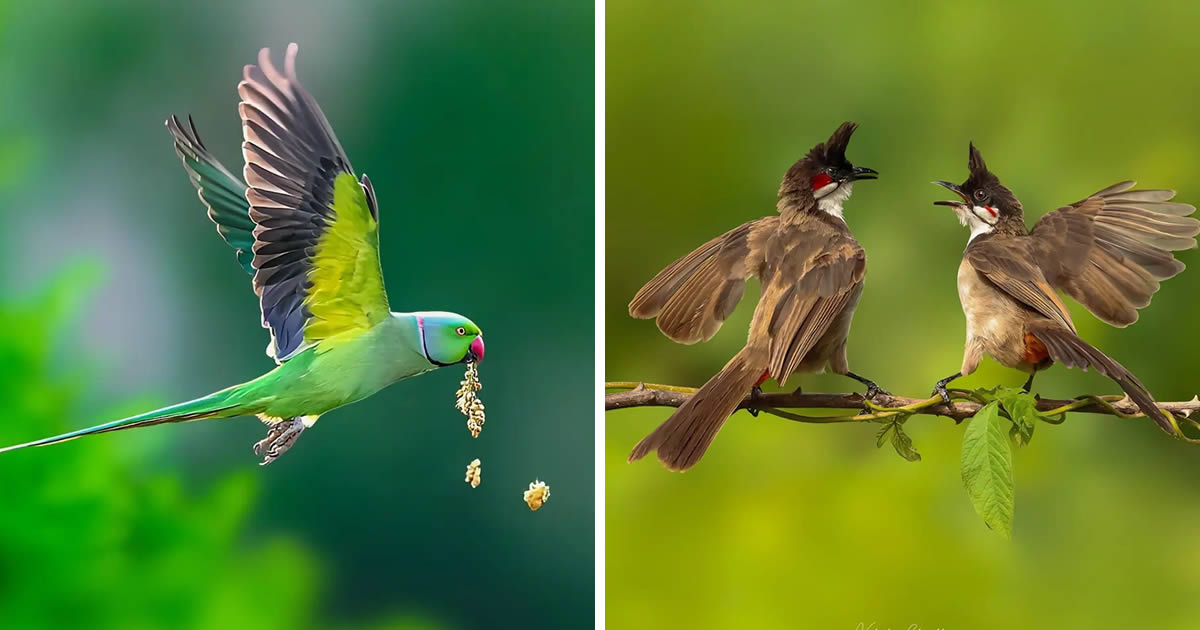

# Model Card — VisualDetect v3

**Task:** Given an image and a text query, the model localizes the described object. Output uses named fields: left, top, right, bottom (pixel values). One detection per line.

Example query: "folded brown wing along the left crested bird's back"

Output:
left=748, top=223, right=866, bottom=385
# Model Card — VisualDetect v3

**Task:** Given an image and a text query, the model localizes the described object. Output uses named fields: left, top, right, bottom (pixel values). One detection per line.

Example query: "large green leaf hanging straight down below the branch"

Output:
left=962, top=402, right=1013, bottom=538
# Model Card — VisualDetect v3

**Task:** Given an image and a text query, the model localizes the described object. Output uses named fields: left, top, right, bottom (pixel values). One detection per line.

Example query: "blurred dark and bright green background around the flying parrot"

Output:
left=0, top=0, right=594, bottom=629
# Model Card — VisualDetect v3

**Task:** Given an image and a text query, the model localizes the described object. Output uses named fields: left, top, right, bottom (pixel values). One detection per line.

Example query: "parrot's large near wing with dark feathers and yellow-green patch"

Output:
left=238, top=43, right=389, bottom=362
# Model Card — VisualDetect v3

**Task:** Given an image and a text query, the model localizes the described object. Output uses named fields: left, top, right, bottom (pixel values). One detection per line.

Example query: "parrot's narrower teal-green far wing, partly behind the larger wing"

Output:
left=167, top=116, right=254, bottom=275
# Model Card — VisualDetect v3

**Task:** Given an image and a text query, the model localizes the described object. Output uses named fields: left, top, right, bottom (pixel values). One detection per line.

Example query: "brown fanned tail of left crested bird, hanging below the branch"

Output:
left=629, top=348, right=766, bottom=472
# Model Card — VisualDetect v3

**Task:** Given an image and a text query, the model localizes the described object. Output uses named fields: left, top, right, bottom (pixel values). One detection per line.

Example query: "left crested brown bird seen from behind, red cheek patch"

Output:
left=629, top=122, right=882, bottom=470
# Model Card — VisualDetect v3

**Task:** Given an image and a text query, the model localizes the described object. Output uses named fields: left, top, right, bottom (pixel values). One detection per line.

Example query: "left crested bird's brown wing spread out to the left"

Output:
left=629, top=216, right=779, bottom=343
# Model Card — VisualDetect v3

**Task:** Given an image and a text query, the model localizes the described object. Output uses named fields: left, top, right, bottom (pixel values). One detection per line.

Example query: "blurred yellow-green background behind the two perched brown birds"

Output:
left=605, top=0, right=1200, bottom=630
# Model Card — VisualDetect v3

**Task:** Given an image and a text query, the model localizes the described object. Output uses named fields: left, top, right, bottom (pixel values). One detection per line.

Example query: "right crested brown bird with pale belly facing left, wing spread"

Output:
left=934, top=144, right=1200, bottom=434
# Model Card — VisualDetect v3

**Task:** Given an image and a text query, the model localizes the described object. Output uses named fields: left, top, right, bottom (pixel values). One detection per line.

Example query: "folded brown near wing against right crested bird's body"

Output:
left=962, top=235, right=1075, bottom=332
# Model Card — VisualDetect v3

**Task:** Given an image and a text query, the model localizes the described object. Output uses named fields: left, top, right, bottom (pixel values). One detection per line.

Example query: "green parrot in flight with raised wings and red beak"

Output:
left=0, top=43, right=484, bottom=464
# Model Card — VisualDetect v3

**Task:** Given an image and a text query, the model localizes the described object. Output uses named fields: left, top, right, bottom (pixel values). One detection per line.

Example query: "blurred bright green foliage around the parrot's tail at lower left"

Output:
left=0, top=270, right=319, bottom=629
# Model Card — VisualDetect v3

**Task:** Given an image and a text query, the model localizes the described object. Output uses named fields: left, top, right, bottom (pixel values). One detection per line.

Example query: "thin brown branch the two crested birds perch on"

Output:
left=604, top=382, right=1200, bottom=432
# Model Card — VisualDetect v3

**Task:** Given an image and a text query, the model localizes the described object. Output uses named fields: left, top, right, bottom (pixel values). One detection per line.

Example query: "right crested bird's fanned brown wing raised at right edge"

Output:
left=1030, top=181, right=1200, bottom=326
